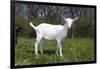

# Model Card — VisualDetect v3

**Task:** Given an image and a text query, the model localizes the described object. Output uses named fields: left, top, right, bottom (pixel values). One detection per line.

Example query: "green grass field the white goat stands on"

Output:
left=15, top=38, right=95, bottom=65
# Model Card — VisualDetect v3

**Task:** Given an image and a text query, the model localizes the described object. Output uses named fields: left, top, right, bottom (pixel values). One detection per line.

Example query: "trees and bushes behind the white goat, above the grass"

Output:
left=15, top=4, right=95, bottom=38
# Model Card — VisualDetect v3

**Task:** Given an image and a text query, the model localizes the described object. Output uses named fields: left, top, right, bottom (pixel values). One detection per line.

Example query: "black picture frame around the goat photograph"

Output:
left=10, top=1, right=96, bottom=68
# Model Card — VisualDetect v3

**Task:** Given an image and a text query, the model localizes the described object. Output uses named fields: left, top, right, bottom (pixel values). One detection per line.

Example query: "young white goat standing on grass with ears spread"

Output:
left=30, top=17, right=78, bottom=56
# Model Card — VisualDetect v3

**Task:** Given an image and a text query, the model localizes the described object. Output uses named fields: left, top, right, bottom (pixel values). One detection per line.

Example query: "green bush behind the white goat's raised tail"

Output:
left=15, top=16, right=43, bottom=37
